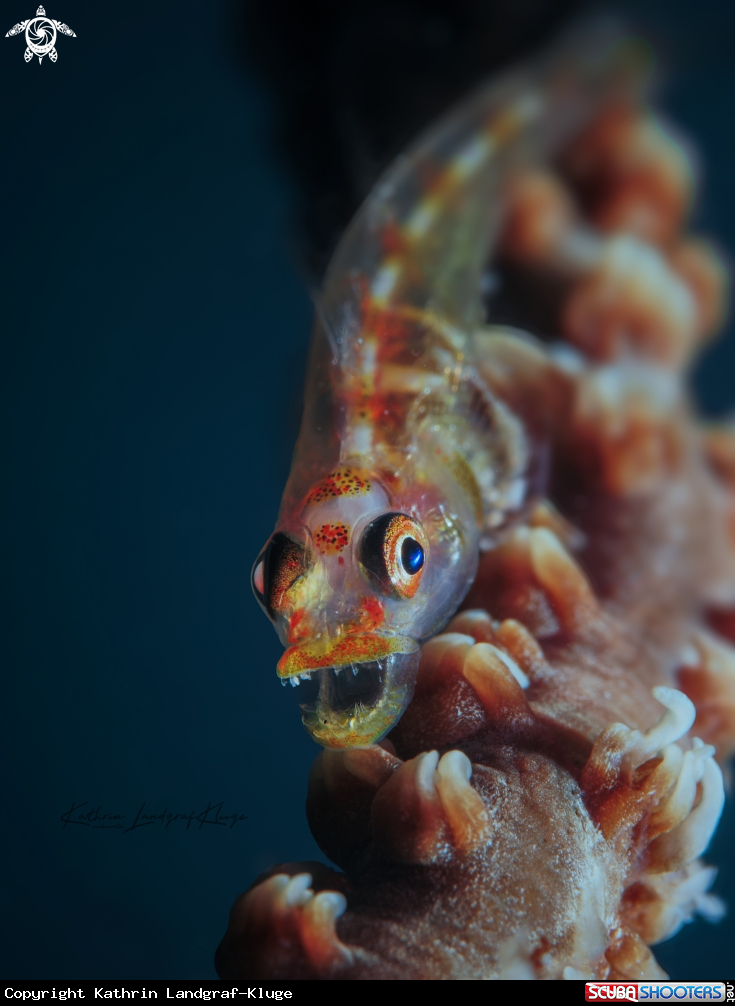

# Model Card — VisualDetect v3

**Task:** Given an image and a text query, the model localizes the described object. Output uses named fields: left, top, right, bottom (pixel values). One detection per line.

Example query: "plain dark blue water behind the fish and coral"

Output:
left=0, top=0, right=735, bottom=980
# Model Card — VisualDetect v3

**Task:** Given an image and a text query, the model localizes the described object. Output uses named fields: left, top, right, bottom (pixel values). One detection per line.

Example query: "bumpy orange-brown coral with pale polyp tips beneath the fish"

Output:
left=217, top=84, right=735, bottom=981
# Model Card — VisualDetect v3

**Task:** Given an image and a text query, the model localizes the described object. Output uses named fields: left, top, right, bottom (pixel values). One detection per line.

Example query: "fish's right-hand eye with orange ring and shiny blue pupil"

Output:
left=360, top=513, right=428, bottom=598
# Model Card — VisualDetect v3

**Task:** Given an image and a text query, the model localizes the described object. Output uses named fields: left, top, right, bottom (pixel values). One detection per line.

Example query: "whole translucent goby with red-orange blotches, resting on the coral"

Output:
left=252, top=25, right=640, bottom=747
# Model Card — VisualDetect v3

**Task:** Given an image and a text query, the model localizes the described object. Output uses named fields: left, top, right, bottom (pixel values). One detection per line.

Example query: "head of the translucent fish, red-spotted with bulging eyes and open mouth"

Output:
left=252, top=467, right=477, bottom=747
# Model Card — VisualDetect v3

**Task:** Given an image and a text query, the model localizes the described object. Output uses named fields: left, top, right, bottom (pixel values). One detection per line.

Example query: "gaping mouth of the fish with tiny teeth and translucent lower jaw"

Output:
left=284, top=650, right=420, bottom=747
